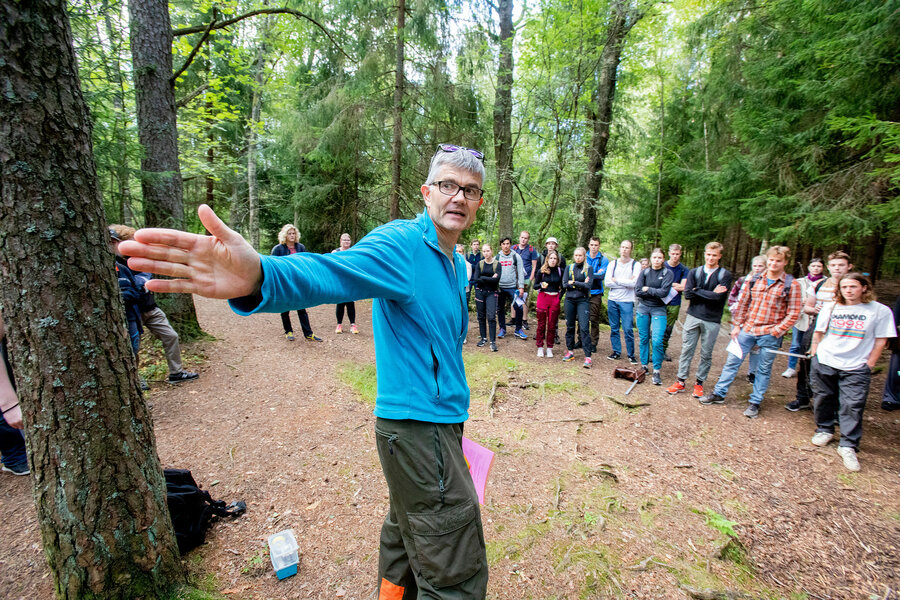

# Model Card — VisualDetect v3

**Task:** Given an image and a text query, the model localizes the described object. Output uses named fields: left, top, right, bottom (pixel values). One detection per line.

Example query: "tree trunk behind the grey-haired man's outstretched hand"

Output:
left=128, top=0, right=200, bottom=339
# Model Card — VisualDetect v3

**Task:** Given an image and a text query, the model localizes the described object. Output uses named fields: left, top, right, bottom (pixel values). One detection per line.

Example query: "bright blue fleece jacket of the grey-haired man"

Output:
left=229, top=212, right=469, bottom=423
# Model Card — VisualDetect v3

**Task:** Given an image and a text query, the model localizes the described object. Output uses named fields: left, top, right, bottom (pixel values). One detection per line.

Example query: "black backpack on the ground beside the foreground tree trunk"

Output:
left=163, top=469, right=247, bottom=554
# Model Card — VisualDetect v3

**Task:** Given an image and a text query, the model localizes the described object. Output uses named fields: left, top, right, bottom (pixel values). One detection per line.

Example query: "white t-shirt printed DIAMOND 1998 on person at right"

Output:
left=816, top=302, right=897, bottom=371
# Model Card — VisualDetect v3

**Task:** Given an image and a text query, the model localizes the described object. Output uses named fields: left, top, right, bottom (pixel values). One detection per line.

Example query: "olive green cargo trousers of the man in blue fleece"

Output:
left=375, top=418, right=488, bottom=600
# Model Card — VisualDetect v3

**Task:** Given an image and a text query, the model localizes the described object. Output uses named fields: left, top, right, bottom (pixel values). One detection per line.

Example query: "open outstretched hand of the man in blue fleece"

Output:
left=119, top=204, right=262, bottom=300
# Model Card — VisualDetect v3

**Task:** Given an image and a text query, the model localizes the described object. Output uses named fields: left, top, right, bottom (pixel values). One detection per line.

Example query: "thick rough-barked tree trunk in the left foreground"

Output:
left=0, top=0, right=184, bottom=598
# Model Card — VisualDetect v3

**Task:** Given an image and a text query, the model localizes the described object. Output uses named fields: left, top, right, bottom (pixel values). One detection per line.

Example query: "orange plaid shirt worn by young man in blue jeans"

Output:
left=731, top=273, right=803, bottom=337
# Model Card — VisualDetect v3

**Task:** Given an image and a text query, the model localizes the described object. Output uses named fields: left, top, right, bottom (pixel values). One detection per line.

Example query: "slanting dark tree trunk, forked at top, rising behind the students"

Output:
left=578, top=0, right=643, bottom=247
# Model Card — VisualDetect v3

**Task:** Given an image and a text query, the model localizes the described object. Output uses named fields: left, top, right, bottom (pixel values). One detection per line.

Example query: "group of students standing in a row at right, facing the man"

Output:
left=457, top=232, right=900, bottom=470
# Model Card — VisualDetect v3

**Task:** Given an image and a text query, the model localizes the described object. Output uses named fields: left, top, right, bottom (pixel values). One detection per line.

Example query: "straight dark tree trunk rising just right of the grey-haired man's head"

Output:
left=494, top=0, right=515, bottom=238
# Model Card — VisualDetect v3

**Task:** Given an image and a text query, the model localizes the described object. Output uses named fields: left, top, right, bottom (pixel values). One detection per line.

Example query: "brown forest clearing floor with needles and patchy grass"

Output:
left=0, top=298, right=900, bottom=600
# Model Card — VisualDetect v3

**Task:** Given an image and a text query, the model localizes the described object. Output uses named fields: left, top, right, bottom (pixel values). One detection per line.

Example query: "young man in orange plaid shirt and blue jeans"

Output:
left=700, top=246, right=803, bottom=419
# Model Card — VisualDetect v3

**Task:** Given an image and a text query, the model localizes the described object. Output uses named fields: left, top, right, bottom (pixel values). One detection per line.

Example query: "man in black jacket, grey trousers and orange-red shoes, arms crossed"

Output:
left=666, top=242, right=734, bottom=398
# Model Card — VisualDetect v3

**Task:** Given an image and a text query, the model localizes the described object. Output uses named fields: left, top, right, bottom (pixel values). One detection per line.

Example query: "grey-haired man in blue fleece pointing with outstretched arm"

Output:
left=123, top=144, right=488, bottom=599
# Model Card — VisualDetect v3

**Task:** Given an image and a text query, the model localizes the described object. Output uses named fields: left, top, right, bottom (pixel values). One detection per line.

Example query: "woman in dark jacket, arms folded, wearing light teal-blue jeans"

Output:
left=634, top=248, right=674, bottom=385
